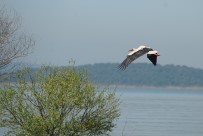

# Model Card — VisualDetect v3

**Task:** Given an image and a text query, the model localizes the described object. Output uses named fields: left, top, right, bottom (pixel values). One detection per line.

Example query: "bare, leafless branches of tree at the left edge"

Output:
left=0, top=7, right=34, bottom=76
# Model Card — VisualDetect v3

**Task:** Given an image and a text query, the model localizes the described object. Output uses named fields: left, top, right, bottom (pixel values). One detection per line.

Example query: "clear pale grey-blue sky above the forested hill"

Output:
left=0, top=0, right=203, bottom=69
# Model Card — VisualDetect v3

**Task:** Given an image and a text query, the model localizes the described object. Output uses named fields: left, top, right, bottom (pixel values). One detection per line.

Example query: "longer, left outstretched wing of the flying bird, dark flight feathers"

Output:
left=118, top=48, right=151, bottom=70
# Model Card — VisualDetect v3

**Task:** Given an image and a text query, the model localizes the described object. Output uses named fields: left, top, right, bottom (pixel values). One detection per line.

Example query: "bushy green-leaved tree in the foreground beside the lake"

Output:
left=0, top=66, right=119, bottom=136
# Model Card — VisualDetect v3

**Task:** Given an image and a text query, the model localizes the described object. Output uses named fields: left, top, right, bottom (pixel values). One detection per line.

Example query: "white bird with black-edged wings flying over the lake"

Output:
left=119, top=45, right=160, bottom=70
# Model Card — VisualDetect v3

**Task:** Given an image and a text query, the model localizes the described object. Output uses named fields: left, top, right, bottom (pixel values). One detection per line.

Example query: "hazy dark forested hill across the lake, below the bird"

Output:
left=79, top=63, right=203, bottom=86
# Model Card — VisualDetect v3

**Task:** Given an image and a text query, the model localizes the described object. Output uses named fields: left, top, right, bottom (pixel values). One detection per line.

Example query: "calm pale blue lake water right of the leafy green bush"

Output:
left=111, top=89, right=203, bottom=136
